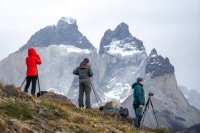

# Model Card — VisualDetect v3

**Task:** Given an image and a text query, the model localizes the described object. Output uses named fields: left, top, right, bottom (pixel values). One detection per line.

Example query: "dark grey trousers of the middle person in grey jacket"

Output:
left=78, top=82, right=91, bottom=108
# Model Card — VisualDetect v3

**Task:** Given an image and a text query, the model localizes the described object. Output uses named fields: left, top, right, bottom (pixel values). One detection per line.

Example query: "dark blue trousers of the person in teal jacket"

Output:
left=133, top=104, right=143, bottom=128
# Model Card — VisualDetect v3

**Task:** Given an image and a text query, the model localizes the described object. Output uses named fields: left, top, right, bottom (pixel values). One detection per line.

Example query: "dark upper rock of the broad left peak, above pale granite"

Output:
left=19, top=17, right=95, bottom=51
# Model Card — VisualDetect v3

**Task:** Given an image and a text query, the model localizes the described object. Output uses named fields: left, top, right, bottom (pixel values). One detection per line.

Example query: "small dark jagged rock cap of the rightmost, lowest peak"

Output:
left=145, top=48, right=174, bottom=78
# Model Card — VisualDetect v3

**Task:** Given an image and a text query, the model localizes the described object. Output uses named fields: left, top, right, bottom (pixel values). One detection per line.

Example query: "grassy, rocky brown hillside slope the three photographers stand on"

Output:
left=0, top=83, right=169, bottom=133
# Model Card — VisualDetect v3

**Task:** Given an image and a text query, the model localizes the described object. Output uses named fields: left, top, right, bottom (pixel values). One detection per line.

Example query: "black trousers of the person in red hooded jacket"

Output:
left=24, top=75, right=38, bottom=95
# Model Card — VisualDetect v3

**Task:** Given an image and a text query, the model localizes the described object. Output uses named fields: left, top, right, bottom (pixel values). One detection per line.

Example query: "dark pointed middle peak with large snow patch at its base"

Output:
left=99, top=22, right=145, bottom=56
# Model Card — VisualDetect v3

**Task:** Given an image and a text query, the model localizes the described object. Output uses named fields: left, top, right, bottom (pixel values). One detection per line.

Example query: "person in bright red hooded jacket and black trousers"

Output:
left=24, top=48, right=42, bottom=96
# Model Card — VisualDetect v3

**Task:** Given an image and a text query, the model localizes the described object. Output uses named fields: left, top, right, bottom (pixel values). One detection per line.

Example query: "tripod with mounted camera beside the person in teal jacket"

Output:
left=141, top=92, right=159, bottom=127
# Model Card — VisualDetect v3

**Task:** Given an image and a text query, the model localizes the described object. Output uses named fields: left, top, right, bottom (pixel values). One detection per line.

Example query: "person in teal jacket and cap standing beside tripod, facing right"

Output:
left=132, top=77, right=145, bottom=129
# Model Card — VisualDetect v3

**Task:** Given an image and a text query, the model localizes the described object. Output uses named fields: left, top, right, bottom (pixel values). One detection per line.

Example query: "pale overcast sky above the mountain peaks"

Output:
left=0, top=0, right=200, bottom=92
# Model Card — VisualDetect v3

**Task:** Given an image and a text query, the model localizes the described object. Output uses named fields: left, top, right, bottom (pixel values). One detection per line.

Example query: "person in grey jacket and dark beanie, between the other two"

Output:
left=73, top=58, right=93, bottom=109
